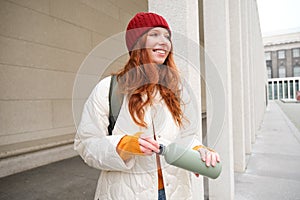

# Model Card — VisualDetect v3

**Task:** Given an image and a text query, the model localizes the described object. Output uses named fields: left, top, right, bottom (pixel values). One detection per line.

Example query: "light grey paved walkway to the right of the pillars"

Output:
left=235, top=101, right=300, bottom=200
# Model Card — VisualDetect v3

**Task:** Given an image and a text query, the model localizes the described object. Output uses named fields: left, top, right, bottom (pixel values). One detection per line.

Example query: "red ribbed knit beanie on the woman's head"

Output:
left=125, top=12, right=171, bottom=51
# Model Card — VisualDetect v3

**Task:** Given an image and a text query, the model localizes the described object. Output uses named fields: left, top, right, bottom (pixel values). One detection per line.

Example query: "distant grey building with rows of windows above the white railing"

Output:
left=263, top=32, right=300, bottom=78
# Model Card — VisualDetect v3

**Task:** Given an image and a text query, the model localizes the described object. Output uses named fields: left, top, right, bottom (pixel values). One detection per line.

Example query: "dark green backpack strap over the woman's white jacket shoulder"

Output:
left=107, top=75, right=124, bottom=135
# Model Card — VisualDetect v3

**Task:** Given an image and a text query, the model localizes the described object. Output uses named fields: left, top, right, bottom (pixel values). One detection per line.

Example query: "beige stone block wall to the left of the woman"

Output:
left=0, top=0, right=148, bottom=175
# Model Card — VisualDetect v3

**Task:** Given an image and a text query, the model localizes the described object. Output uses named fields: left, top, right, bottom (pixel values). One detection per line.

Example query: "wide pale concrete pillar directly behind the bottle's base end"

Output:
left=203, top=0, right=234, bottom=200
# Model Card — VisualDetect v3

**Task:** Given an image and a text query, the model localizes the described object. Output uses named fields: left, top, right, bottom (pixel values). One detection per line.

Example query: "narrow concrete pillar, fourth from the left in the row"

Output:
left=240, top=1, right=252, bottom=154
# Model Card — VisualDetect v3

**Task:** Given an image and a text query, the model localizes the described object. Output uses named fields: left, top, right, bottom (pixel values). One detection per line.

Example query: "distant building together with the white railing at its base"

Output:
left=263, top=32, right=300, bottom=101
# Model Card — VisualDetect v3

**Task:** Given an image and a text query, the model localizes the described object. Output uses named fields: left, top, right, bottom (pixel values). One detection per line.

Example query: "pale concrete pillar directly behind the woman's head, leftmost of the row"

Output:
left=148, top=0, right=204, bottom=200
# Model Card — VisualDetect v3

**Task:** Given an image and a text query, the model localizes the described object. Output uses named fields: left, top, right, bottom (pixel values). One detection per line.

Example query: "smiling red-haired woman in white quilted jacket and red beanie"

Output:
left=74, top=13, right=220, bottom=200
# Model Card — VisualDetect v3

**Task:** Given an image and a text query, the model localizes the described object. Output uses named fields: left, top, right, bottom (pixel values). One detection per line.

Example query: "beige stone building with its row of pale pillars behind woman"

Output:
left=0, top=0, right=268, bottom=200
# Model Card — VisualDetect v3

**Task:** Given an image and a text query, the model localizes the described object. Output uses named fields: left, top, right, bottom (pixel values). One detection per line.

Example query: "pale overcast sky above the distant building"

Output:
left=257, top=0, right=300, bottom=36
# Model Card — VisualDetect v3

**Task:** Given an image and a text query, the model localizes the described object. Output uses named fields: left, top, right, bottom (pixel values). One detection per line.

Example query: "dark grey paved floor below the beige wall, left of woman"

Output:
left=0, top=157, right=99, bottom=200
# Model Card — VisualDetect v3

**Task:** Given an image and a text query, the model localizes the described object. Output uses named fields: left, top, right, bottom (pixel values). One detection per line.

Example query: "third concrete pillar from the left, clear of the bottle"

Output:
left=229, top=0, right=246, bottom=172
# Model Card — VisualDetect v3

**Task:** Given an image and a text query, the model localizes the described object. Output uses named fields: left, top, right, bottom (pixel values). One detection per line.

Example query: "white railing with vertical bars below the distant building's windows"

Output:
left=268, top=77, right=300, bottom=100
